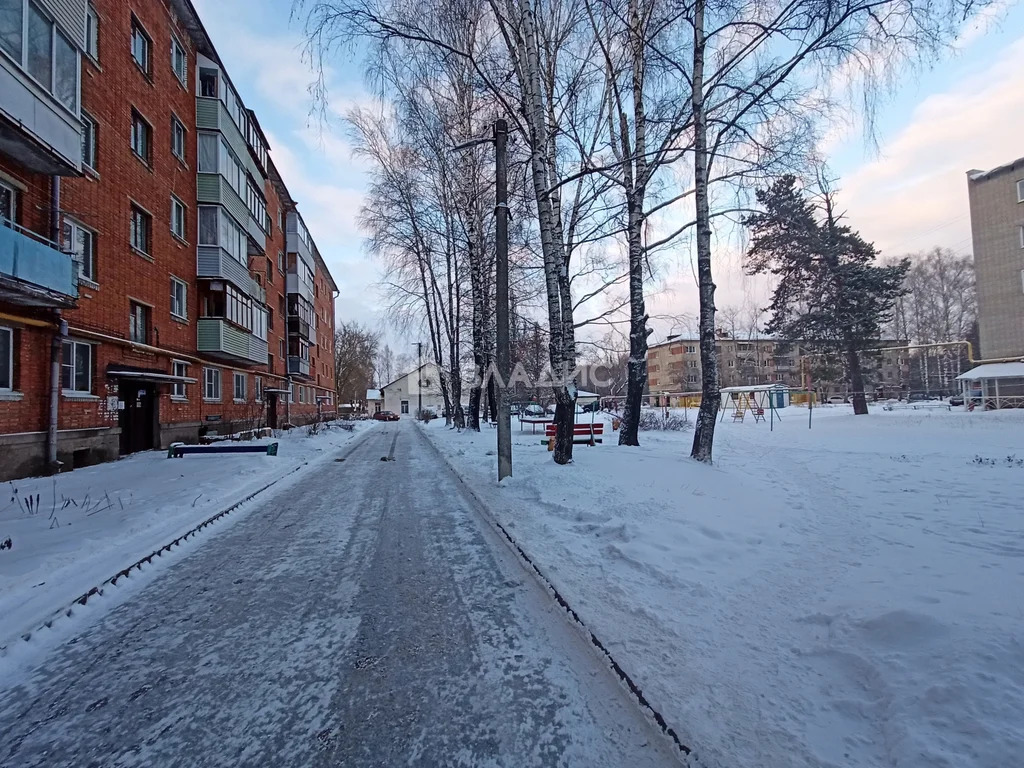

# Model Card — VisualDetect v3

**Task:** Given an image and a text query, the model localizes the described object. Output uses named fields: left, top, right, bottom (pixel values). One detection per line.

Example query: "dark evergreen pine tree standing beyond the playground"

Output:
left=744, top=176, right=909, bottom=414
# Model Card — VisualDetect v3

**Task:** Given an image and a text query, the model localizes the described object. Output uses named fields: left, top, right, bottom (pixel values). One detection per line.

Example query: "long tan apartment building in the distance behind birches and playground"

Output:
left=647, top=335, right=910, bottom=397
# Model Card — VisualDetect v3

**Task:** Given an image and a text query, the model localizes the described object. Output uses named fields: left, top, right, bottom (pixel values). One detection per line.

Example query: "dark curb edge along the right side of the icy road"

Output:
left=413, top=423, right=699, bottom=765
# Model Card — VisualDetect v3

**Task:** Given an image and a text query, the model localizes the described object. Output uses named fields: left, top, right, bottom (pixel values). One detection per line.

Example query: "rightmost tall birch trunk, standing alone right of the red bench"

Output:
left=690, top=0, right=722, bottom=464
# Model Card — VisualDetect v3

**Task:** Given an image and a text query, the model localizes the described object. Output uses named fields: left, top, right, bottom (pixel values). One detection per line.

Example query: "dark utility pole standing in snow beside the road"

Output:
left=495, top=119, right=512, bottom=482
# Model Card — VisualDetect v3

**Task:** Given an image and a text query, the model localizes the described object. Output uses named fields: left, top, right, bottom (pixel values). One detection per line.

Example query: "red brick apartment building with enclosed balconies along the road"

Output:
left=0, top=0, right=337, bottom=479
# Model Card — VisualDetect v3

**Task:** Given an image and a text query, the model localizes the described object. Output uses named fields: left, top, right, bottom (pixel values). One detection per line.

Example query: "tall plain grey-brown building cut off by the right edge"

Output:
left=967, top=158, right=1024, bottom=358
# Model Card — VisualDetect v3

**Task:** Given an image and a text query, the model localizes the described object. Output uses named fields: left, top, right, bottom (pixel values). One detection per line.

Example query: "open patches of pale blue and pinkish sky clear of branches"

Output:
left=194, top=0, right=1024, bottom=349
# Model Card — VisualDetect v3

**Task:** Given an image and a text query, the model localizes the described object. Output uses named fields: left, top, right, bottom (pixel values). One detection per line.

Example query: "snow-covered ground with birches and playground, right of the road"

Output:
left=426, top=406, right=1024, bottom=768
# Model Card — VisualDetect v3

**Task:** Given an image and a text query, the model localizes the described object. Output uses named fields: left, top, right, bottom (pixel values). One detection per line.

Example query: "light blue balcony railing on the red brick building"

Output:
left=0, top=218, right=78, bottom=307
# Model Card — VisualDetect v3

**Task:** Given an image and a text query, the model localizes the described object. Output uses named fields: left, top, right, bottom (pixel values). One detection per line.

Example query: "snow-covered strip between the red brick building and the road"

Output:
left=0, top=421, right=376, bottom=648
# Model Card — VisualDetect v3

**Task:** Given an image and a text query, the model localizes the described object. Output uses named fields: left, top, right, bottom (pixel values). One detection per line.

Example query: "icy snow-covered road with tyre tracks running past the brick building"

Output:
left=0, top=423, right=677, bottom=768
